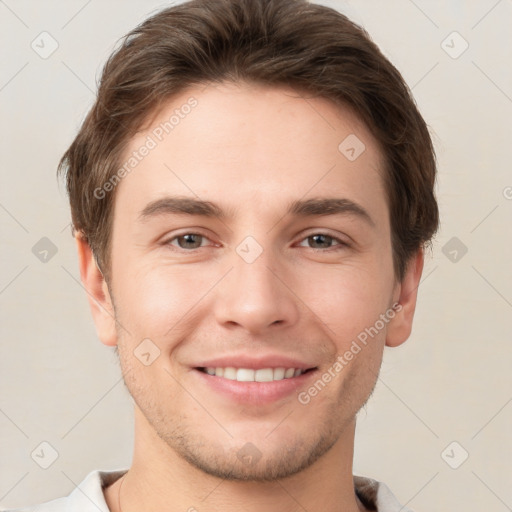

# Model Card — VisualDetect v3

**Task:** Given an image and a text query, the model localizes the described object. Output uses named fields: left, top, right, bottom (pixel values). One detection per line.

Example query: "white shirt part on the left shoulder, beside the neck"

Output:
left=0, top=469, right=127, bottom=512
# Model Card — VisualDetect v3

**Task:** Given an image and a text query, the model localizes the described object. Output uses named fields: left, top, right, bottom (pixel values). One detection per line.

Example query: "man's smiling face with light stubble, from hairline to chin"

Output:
left=103, top=80, right=399, bottom=480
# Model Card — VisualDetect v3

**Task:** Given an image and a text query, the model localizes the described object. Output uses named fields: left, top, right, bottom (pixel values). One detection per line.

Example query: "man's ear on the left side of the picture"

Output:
left=75, top=232, right=117, bottom=347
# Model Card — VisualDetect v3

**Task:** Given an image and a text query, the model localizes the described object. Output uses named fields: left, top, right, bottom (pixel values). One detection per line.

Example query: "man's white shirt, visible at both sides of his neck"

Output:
left=7, top=469, right=412, bottom=512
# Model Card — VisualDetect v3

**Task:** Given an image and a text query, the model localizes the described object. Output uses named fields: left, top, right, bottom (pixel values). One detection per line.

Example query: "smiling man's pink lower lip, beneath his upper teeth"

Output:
left=193, top=368, right=317, bottom=405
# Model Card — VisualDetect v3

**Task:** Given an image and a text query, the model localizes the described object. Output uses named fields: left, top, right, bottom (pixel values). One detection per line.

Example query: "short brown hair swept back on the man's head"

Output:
left=59, top=0, right=439, bottom=280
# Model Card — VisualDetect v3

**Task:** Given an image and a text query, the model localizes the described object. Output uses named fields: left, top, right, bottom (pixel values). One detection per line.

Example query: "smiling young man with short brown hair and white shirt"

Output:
left=12, top=0, right=438, bottom=512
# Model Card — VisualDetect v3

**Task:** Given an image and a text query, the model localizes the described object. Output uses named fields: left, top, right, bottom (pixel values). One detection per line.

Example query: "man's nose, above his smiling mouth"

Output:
left=214, top=245, right=299, bottom=334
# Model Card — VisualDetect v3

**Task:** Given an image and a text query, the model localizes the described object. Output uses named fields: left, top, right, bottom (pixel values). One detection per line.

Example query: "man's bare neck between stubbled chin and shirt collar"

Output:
left=105, top=407, right=365, bottom=512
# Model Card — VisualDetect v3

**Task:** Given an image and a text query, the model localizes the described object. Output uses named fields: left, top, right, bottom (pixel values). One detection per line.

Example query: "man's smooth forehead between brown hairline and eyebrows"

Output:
left=116, top=83, right=386, bottom=226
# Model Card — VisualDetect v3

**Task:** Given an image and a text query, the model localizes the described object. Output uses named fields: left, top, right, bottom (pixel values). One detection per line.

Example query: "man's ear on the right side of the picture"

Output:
left=386, top=249, right=424, bottom=347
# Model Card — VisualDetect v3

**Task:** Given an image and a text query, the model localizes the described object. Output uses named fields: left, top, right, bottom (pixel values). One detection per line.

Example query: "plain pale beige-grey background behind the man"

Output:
left=0, top=0, right=512, bottom=512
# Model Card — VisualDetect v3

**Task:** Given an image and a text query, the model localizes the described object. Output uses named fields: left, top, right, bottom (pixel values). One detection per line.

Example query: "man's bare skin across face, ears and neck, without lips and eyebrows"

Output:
left=77, top=83, right=423, bottom=512
